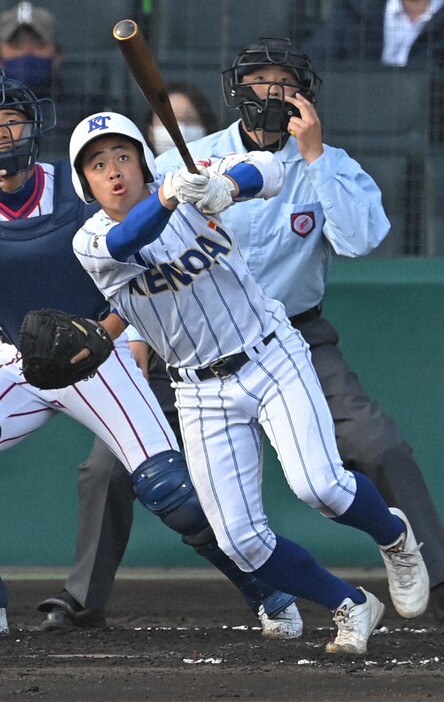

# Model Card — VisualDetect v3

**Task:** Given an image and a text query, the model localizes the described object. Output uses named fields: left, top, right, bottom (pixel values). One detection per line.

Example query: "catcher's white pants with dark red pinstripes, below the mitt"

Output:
left=0, top=335, right=178, bottom=473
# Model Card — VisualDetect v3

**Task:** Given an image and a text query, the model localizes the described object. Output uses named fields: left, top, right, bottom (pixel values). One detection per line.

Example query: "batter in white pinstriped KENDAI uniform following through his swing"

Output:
left=70, top=113, right=429, bottom=653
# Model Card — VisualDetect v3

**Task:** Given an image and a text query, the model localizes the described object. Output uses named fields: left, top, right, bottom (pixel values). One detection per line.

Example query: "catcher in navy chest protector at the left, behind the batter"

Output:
left=0, top=73, right=301, bottom=635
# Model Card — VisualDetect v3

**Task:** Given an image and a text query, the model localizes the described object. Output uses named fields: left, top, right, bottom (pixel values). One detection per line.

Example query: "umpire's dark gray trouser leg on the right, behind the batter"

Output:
left=297, top=317, right=444, bottom=587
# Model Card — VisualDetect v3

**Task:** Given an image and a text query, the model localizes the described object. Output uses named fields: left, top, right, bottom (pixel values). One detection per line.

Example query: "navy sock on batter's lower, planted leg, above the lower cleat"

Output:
left=255, top=534, right=365, bottom=611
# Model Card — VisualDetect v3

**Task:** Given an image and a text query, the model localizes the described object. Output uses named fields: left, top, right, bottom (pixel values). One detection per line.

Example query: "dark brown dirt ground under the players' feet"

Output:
left=0, top=573, right=444, bottom=702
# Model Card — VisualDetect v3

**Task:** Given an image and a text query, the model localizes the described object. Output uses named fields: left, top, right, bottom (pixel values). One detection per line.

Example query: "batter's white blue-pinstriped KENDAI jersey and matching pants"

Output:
left=73, top=161, right=356, bottom=571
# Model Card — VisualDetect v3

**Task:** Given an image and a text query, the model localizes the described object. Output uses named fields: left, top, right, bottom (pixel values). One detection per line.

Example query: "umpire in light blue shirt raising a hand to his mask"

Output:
left=150, top=34, right=444, bottom=633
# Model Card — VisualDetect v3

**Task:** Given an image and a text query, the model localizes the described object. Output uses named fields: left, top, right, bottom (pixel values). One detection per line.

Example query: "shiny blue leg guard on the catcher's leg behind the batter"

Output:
left=132, top=451, right=296, bottom=617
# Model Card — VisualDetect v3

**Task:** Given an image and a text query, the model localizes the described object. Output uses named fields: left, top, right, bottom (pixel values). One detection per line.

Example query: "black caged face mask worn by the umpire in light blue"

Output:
left=222, top=37, right=321, bottom=145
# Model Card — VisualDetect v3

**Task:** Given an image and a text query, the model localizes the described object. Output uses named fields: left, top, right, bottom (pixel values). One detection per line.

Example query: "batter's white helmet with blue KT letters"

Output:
left=69, top=112, right=156, bottom=202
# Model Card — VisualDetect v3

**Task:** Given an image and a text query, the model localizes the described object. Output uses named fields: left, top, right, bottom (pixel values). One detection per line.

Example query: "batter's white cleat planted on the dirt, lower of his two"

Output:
left=325, top=587, right=385, bottom=654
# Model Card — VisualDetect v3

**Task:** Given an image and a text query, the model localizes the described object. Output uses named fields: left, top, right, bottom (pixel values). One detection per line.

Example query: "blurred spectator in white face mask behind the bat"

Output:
left=146, top=81, right=219, bottom=156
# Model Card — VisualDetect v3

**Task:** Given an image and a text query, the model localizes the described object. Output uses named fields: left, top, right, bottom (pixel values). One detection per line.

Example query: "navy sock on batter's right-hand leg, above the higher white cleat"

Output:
left=332, top=471, right=406, bottom=546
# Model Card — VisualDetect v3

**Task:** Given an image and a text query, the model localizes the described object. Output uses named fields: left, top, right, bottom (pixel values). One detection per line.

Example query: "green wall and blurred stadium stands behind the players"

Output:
left=0, top=0, right=444, bottom=568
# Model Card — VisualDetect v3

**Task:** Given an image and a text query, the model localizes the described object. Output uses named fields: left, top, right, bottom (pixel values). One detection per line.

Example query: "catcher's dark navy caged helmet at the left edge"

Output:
left=0, top=69, right=56, bottom=175
